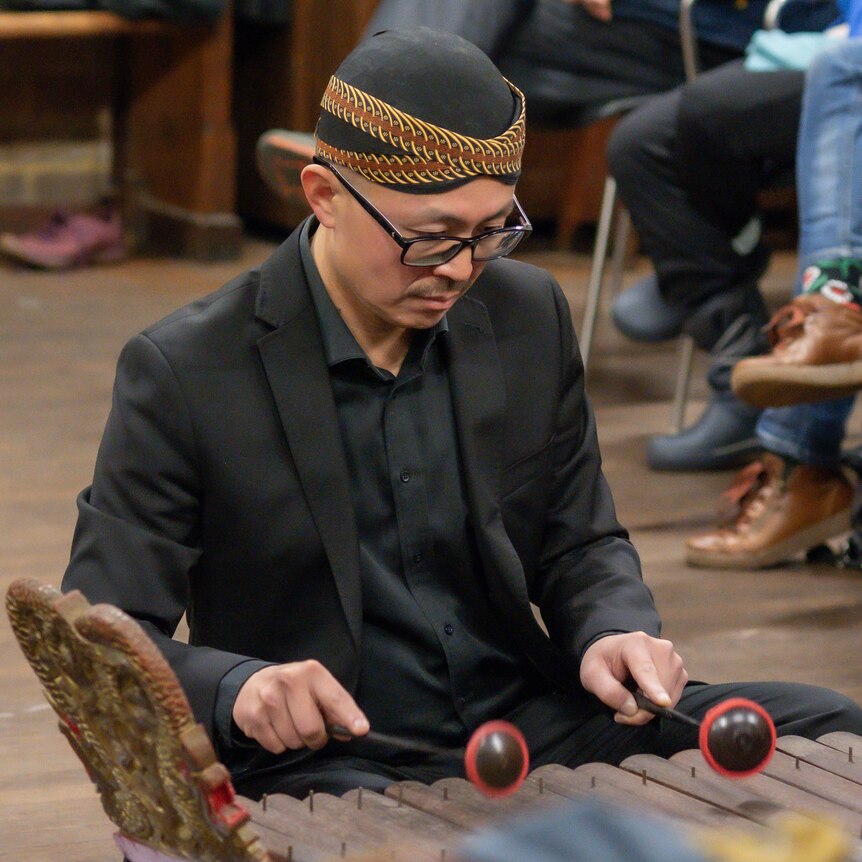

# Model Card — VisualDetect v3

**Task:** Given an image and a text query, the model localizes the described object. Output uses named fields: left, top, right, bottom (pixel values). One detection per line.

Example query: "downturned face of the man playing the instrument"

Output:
left=322, top=172, right=514, bottom=332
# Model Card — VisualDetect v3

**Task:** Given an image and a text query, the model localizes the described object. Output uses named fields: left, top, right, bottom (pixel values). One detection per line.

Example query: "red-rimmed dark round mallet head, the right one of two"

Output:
left=699, top=697, right=775, bottom=778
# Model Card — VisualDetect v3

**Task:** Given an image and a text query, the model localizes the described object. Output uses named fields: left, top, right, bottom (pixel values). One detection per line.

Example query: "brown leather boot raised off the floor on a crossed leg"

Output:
left=731, top=293, right=862, bottom=407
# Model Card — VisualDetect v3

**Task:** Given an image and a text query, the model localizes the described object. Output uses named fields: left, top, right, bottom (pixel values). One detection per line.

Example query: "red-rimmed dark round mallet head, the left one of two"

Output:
left=464, top=721, right=530, bottom=796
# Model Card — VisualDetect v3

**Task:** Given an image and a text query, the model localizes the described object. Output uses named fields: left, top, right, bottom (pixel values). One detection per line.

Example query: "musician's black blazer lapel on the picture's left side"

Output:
left=253, top=234, right=362, bottom=648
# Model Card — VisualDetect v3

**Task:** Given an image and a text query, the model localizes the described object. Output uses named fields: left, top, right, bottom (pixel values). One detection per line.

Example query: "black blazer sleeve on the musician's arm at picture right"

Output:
left=532, top=283, right=661, bottom=659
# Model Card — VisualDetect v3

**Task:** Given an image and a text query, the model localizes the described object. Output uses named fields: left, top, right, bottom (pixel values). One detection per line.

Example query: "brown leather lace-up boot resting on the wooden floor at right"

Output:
left=686, top=452, right=853, bottom=569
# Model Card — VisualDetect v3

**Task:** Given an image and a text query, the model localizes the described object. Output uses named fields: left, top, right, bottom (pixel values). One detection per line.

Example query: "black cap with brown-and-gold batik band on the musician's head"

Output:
left=316, top=27, right=525, bottom=193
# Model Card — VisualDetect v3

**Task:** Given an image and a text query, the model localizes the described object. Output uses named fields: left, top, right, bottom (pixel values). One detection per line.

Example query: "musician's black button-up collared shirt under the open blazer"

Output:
left=300, top=221, right=542, bottom=759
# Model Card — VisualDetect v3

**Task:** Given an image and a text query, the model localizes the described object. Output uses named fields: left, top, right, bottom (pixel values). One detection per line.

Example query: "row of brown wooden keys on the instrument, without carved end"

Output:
left=241, top=733, right=862, bottom=862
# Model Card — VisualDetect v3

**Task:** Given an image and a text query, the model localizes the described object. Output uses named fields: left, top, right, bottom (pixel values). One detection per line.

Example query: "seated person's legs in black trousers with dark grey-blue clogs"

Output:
left=608, top=61, right=803, bottom=469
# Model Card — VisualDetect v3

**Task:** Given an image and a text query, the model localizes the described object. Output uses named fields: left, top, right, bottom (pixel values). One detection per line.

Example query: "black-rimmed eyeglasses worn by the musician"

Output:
left=314, top=156, right=533, bottom=266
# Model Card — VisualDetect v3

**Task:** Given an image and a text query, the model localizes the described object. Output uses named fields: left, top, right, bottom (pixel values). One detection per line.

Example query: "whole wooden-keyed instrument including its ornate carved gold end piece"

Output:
left=6, top=579, right=862, bottom=862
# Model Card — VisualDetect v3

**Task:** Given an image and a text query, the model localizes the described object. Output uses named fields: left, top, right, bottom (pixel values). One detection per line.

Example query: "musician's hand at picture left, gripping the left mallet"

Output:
left=233, top=659, right=368, bottom=754
